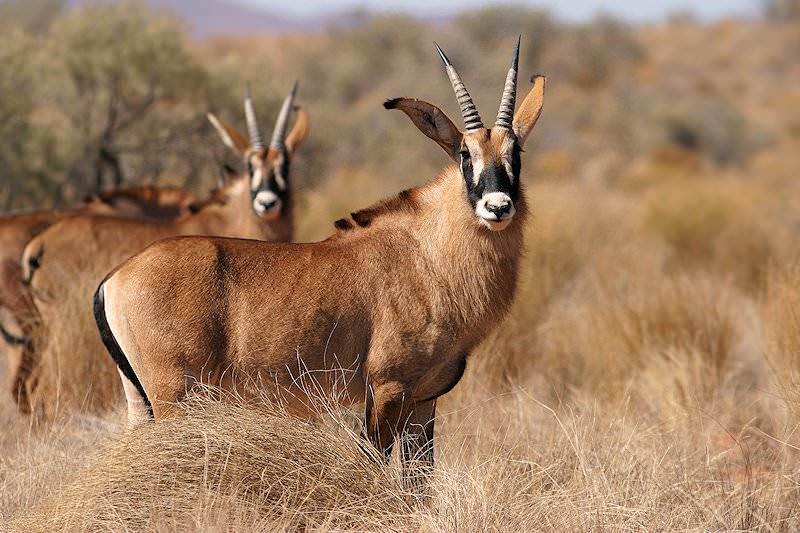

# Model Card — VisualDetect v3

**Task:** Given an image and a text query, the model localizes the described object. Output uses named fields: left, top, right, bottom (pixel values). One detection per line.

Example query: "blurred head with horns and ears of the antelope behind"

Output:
left=208, top=82, right=308, bottom=220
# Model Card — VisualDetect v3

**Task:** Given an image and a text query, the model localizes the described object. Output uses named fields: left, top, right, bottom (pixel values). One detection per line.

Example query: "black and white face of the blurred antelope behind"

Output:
left=247, top=153, right=289, bottom=220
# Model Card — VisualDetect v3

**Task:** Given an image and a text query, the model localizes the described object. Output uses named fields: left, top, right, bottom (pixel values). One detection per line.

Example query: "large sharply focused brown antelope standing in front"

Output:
left=94, top=43, right=545, bottom=482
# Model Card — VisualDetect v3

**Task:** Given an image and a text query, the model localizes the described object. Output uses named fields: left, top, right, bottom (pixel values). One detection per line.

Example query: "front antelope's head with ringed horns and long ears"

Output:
left=383, top=36, right=545, bottom=231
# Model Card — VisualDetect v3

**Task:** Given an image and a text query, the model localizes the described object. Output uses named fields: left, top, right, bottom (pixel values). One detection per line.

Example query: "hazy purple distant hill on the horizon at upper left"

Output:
left=66, top=0, right=328, bottom=37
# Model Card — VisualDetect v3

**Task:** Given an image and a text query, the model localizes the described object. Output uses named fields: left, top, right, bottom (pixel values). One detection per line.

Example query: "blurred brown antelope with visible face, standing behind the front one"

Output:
left=22, top=84, right=308, bottom=414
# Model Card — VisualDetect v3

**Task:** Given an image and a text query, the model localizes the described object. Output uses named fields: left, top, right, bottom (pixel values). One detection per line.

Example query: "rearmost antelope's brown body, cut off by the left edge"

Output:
left=0, top=186, right=195, bottom=406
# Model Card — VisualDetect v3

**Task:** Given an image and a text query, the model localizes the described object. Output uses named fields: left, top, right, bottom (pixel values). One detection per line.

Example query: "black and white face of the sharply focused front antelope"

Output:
left=460, top=135, right=522, bottom=231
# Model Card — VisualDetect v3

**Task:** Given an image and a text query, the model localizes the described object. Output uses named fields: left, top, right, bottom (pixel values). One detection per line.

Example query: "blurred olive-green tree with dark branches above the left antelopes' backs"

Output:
left=43, top=4, right=216, bottom=194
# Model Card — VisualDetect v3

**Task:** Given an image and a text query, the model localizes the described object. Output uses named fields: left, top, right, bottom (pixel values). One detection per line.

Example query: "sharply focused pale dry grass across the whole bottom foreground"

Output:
left=0, top=373, right=800, bottom=531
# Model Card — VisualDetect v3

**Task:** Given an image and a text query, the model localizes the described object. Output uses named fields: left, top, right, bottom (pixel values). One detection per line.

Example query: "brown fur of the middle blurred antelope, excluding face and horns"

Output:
left=20, top=112, right=308, bottom=414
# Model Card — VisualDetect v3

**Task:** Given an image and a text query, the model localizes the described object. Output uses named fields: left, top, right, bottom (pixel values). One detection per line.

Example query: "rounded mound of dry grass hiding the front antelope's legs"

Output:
left=7, top=399, right=410, bottom=531
